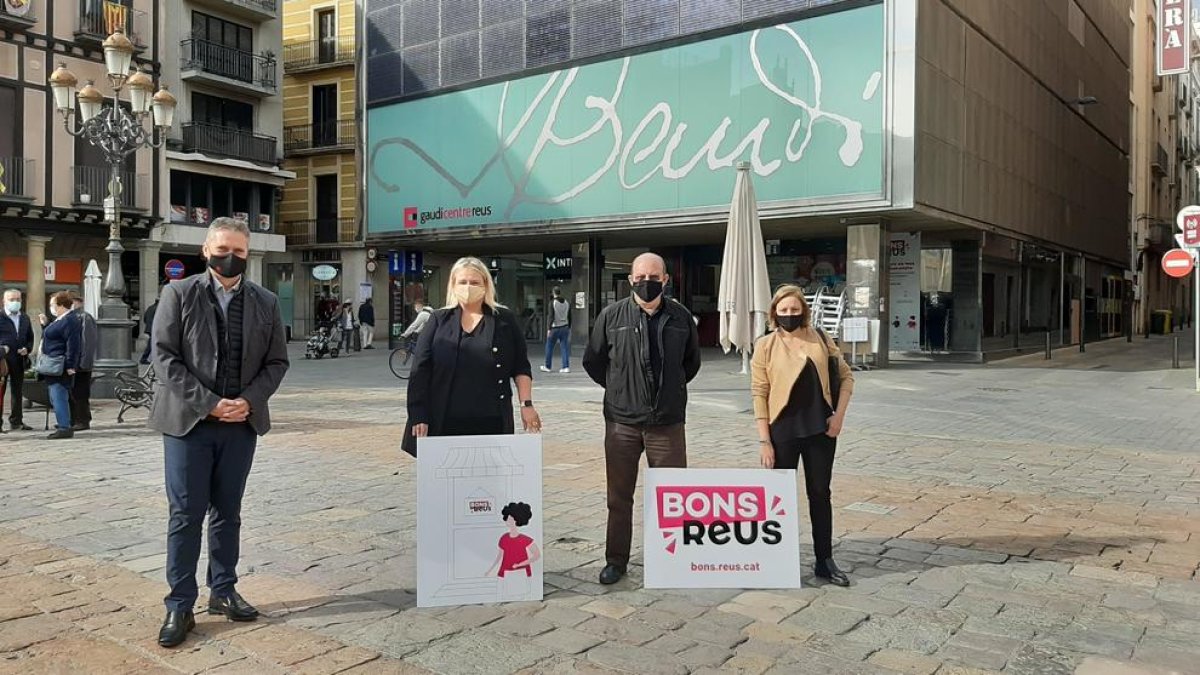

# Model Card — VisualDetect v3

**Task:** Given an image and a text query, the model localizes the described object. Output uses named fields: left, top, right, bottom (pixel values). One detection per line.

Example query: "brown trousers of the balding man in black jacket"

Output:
left=604, top=422, right=688, bottom=567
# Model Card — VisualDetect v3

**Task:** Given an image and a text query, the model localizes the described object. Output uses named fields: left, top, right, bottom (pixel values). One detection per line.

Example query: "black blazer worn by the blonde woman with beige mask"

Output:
left=401, top=307, right=533, bottom=458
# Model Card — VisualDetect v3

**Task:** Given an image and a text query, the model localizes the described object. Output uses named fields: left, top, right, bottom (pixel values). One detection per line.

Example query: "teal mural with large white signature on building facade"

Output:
left=367, top=5, right=884, bottom=233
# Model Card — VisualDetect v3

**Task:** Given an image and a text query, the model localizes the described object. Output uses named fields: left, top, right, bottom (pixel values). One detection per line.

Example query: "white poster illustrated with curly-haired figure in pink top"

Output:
left=416, top=434, right=542, bottom=607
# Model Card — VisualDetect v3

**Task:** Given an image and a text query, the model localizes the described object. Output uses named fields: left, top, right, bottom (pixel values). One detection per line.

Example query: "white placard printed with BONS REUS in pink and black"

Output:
left=643, top=468, right=800, bottom=589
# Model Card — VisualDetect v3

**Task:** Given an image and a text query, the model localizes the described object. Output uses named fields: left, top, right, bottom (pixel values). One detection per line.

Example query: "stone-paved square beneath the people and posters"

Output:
left=0, top=338, right=1200, bottom=675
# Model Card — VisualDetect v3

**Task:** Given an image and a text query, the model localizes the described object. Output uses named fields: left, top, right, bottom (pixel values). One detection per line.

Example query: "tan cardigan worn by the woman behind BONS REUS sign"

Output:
left=750, top=330, right=854, bottom=422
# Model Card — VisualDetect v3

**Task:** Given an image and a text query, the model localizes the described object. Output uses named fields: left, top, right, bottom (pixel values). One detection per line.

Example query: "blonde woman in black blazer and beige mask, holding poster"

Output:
left=402, top=258, right=541, bottom=456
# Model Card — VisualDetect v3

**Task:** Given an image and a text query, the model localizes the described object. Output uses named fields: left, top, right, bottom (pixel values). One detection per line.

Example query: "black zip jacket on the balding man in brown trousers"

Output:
left=583, top=298, right=700, bottom=426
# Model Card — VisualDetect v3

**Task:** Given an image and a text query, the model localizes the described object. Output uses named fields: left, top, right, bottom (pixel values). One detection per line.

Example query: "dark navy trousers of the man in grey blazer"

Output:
left=162, top=420, right=258, bottom=611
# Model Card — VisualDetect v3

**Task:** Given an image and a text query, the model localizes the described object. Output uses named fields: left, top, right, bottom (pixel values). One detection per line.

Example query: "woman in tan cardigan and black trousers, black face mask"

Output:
left=750, top=286, right=854, bottom=586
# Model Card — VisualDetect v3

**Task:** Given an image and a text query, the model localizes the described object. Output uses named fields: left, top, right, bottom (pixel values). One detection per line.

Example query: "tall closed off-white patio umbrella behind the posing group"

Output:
left=716, top=162, right=770, bottom=375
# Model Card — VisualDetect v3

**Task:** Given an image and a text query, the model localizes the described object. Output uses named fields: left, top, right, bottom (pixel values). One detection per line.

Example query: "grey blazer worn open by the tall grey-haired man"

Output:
left=150, top=271, right=288, bottom=436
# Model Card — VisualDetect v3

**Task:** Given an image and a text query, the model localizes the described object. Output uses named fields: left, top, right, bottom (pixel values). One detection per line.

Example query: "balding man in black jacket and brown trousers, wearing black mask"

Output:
left=583, top=253, right=700, bottom=584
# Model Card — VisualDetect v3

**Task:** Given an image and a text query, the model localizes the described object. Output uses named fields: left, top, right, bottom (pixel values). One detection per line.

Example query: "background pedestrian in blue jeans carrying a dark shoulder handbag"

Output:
left=36, top=291, right=80, bottom=441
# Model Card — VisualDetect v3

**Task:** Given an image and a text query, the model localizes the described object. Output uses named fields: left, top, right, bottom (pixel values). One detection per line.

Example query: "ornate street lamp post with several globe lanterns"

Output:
left=49, top=28, right=175, bottom=390
